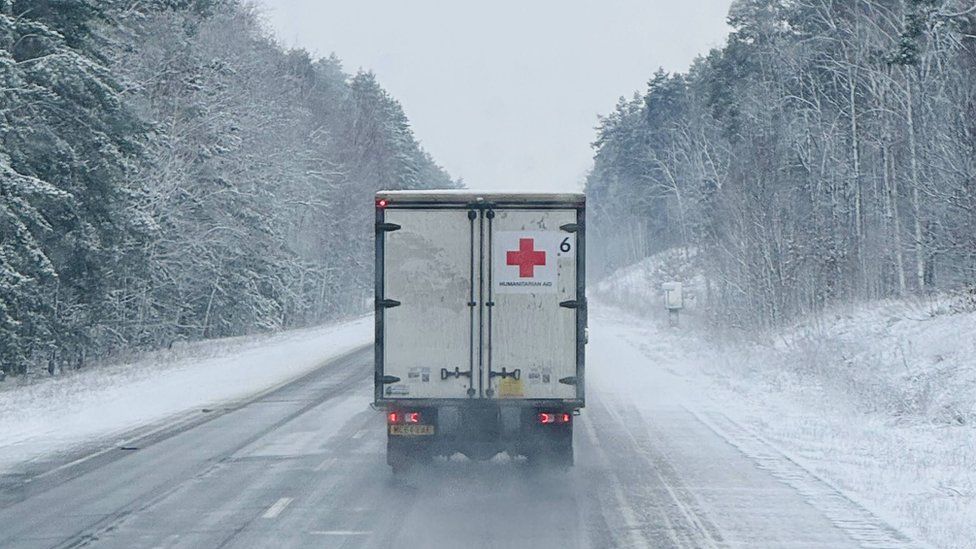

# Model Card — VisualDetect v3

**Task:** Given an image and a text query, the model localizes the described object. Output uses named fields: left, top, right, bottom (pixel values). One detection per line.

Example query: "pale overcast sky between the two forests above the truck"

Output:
left=252, top=0, right=731, bottom=190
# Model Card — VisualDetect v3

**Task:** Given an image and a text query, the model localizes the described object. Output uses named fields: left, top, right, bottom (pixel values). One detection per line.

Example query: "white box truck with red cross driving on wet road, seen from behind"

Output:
left=373, top=190, right=587, bottom=474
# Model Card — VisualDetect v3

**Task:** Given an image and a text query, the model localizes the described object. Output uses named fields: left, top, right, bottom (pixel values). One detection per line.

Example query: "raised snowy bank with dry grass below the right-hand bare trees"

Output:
left=765, top=297, right=976, bottom=426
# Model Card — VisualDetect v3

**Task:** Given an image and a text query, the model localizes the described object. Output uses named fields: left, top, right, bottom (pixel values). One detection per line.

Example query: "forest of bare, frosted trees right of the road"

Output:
left=586, top=0, right=976, bottom=328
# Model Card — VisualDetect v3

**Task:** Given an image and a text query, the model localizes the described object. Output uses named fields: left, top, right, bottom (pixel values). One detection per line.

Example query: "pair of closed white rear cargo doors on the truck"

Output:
left=376, top=201, right=585, bottom=400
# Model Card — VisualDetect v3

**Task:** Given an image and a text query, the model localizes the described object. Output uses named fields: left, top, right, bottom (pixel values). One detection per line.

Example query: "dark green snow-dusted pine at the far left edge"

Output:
left=0, top=3, right=149, bottom=370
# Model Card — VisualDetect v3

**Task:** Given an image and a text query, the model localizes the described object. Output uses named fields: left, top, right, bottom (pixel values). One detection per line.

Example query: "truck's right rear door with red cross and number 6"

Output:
left=483, top=208, right=578, bottom=399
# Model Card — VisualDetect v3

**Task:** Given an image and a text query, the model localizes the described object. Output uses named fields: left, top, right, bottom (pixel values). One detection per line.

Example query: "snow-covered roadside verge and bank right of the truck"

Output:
left=591, top=254, right=976, bottom=548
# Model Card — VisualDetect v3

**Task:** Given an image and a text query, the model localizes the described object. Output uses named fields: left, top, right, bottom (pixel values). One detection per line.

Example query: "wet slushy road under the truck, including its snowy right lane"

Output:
left=0, top=330, right=910, bottom=548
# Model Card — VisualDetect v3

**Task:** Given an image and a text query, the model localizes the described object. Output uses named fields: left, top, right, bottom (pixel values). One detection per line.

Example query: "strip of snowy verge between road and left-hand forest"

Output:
left=0, top=317, right=373, bottom=473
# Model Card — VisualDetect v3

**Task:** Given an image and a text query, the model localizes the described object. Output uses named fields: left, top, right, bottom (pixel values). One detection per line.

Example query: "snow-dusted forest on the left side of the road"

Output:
left=0, top=0, right=458, bottom=374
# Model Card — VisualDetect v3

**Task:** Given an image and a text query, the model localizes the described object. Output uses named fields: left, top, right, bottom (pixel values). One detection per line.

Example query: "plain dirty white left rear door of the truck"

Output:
left=377, top=208, right=481, bottom=399
